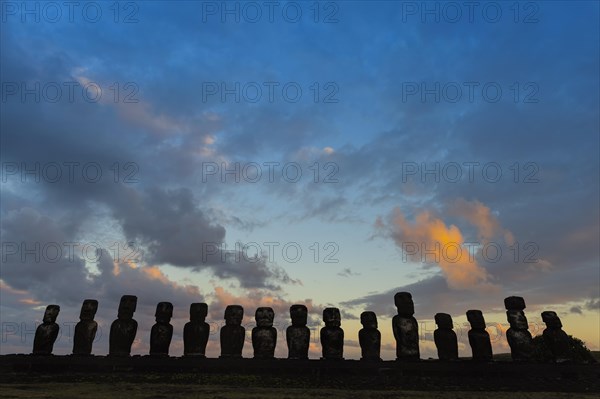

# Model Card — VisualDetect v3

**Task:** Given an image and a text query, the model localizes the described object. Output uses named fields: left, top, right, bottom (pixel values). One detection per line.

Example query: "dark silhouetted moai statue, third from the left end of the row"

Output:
left=108, top=295, right=137, bottom=356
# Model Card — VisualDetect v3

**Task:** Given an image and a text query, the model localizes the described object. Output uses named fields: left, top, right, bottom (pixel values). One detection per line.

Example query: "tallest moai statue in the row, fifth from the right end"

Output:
left=392, top=292, right=420, bottom=360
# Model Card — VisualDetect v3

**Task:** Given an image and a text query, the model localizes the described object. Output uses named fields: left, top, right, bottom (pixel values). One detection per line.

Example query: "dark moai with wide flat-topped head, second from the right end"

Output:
left=504, top=296, right=533, bottom=362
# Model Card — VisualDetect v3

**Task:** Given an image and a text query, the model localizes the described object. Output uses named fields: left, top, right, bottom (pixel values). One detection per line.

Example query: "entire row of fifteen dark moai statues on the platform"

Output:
left=33, top=292, right=570, bottom=361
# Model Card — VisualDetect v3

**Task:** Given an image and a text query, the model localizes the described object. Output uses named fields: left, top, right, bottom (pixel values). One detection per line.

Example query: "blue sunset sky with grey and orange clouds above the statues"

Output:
left=0, top=1, right=600, bottom=360
